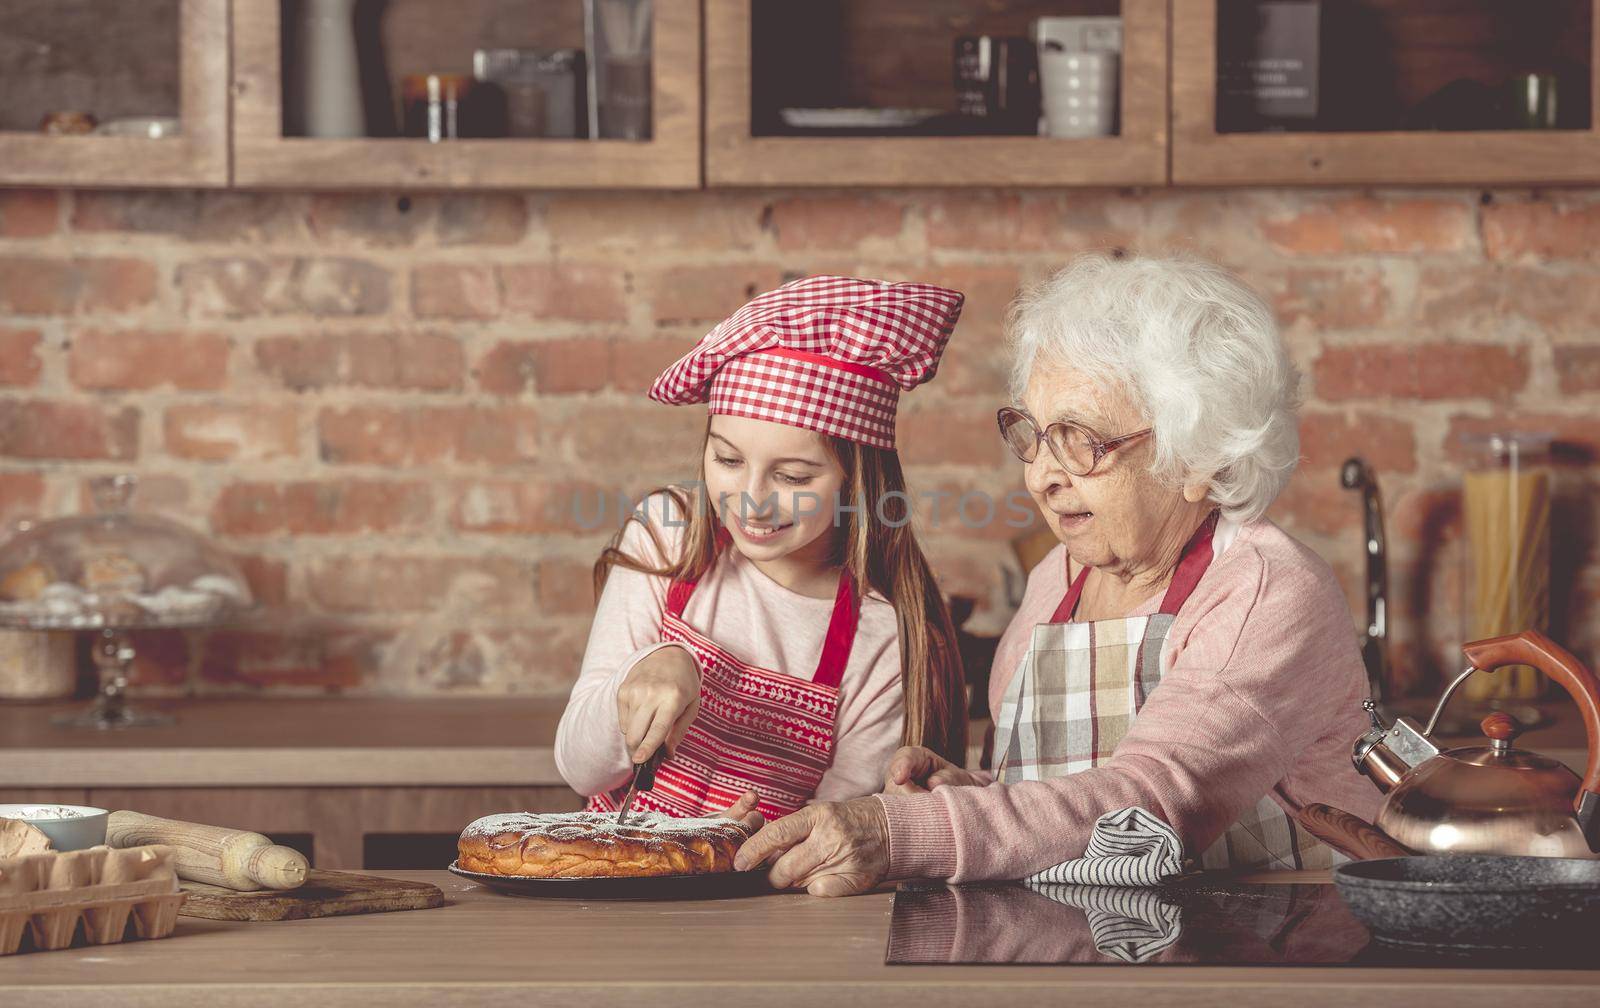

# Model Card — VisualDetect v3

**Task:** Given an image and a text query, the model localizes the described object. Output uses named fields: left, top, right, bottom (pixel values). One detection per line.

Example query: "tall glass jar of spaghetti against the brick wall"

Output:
left=1461, top=432, right=1550, bottom=702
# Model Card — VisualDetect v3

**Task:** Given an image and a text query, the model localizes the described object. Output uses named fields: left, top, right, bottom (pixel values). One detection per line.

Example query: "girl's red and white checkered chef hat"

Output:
left=650, top=277, right=965, bottom=448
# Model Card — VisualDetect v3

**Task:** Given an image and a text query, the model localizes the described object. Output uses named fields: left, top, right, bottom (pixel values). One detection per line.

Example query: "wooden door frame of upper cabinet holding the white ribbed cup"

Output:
left=706, top=0, right=1168, bottom=187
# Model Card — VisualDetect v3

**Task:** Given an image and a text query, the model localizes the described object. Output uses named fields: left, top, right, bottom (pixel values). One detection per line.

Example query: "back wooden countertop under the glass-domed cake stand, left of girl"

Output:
left=0, top=696, right=566, bottom=789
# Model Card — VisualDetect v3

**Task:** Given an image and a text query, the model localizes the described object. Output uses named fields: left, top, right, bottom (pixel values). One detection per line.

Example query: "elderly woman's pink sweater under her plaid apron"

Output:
left=878, top=520, right=1381, bottom=882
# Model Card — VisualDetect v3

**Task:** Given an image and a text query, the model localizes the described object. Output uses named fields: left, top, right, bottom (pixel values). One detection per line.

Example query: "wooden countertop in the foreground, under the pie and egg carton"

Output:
left=0, top=872, right=1600, bottom=1008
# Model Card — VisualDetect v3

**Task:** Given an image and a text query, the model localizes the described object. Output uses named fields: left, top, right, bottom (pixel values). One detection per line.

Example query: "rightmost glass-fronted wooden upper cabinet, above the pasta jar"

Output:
left=1171, top=0, right=1600, bottom=186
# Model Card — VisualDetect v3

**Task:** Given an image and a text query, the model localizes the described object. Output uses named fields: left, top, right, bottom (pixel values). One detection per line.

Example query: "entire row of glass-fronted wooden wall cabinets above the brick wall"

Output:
left=0, top=0, right=1600, bottom=189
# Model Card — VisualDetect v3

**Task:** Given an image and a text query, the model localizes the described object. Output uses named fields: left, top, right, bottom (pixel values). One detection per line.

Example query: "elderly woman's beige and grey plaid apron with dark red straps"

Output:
left=995, top=512, right=1342, bottom=869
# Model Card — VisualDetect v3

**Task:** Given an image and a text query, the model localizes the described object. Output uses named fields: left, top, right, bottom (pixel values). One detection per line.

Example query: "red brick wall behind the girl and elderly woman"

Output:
left=0, top=190, right=1600, bottom=693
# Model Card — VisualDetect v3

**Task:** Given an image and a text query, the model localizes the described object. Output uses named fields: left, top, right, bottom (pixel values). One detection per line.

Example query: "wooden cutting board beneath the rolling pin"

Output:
left=178, top=869, right=445, bottom=920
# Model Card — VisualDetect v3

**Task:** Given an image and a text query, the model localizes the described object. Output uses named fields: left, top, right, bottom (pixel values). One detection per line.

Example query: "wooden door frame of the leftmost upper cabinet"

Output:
left=0, top=0, right=229, bottom=189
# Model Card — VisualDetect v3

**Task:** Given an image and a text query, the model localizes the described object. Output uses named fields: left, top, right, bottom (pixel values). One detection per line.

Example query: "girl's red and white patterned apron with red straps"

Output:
left=587, top=556, right=859, bottom=822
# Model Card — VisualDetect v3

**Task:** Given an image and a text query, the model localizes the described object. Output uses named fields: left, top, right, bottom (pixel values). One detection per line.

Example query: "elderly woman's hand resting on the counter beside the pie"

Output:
left=733, top=797, right=890, bottom=896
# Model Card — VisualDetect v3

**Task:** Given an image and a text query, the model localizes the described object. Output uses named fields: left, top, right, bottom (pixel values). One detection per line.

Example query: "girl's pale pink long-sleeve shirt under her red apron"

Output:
left=555, top=494, right=906, bottom=802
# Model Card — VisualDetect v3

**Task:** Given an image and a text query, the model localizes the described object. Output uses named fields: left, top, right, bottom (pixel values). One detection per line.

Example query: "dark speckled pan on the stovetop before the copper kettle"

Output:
left=1333, top=854, right=1600, bottom=949
